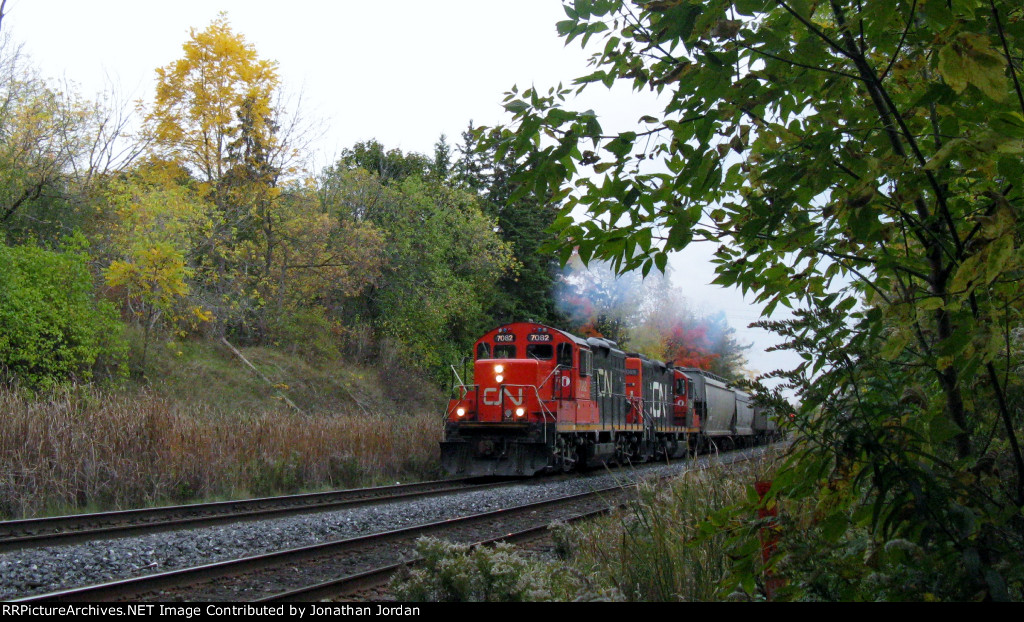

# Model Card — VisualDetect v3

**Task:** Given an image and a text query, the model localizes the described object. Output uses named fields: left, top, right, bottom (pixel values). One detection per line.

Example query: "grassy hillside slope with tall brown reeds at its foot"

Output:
left=0, top=341, right=443, bottom=519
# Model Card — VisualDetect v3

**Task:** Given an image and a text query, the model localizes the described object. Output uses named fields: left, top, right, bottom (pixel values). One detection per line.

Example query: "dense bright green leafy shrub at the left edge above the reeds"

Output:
left=0, top=240, right=126, bottom=388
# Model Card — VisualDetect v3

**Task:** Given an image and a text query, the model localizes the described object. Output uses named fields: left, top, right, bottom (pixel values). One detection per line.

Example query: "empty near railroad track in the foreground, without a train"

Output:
left=14, top=446, right=770, bottom=603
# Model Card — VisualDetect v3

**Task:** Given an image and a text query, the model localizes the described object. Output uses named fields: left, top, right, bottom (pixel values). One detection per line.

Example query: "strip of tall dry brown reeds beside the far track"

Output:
left=0, top=387, right=441, bottom=519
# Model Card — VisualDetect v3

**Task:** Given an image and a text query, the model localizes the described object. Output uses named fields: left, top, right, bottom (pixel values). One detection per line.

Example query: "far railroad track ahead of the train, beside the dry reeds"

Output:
left=0, top=480, right=499, bottom=552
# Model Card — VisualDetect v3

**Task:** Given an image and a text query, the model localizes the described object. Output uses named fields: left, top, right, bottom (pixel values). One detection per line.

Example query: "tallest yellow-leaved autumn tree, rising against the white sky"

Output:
left=146, top=13, right=289, bottom=332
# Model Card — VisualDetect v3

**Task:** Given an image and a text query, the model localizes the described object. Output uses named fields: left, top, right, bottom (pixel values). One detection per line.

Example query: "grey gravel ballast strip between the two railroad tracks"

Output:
left=0, top=450, right=753, bottom=599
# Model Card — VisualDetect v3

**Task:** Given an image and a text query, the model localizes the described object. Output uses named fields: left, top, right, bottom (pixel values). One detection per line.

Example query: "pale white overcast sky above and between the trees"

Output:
left=3, top=0, right=795, bottom=381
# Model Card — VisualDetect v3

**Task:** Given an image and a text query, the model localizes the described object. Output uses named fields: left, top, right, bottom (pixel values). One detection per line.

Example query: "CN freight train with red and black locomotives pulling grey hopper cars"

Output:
left=441, top=322, right=774, bottom=476
